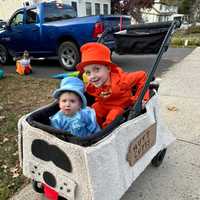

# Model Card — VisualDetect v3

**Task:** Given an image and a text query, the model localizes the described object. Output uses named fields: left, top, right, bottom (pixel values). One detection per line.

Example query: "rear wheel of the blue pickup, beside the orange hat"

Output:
left=58, top=41, right=80, bottom=71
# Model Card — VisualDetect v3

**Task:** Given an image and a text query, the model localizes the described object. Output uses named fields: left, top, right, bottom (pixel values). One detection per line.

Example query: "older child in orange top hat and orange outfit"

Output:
left=77, top=42, right=148, bottom=128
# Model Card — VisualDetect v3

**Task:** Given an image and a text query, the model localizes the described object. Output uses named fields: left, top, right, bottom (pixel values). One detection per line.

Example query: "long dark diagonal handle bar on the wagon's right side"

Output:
left=128, top=20, right=180, bottom=120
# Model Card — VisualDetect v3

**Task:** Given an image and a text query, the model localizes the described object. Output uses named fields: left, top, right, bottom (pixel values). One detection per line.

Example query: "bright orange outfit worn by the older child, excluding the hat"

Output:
left=86, top=68, right=149, bottom=127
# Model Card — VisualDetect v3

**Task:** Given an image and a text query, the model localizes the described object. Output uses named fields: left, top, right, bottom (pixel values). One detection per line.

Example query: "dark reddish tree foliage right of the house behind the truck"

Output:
left=111, top=0, right=154, bottom=22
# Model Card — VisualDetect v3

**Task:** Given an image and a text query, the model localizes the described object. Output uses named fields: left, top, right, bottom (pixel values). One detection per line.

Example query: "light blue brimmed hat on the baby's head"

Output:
left=53, top=77, right=87, bottom=108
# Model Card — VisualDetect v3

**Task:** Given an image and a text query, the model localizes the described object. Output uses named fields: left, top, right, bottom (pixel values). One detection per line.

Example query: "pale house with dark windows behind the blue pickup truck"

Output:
left=0, top=0, right=111, bottom=21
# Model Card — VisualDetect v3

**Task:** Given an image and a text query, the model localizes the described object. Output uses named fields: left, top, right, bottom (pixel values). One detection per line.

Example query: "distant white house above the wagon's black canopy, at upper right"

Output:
left=142, top=0, right=178, bottom=23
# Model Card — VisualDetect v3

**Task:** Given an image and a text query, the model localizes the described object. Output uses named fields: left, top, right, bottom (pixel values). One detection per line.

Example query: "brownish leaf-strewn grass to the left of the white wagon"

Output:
left=0, top=74, right=58, bottom=200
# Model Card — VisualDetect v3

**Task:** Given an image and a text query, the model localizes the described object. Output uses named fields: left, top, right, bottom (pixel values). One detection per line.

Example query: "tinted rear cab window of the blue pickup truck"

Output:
left=44, top=3, right=76, bottom=22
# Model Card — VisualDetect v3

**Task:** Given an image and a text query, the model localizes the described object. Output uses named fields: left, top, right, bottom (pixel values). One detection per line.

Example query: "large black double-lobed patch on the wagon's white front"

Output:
left=31, top=139, right=72, bottom=172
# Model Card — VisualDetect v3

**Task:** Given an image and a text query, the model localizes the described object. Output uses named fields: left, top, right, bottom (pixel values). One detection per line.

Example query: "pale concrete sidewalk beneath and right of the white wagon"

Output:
left=11, top=48, right=200, bottom=200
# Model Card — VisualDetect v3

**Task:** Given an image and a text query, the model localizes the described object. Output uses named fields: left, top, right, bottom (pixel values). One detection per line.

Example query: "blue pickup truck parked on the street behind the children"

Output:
left=0, top=2, right=130, bottom=70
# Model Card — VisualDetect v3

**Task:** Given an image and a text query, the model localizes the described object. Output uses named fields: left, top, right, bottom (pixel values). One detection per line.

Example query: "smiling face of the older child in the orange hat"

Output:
left=84, top=64, right=110, bottom=87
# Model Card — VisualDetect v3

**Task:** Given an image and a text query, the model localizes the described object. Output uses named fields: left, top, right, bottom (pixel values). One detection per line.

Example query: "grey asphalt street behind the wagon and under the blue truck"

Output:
left=2, top=48, right=193, bottom=78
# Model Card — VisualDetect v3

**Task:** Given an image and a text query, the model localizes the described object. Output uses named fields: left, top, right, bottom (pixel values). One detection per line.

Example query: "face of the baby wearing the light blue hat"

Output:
left=59, top=92, right=82, bottom=116
